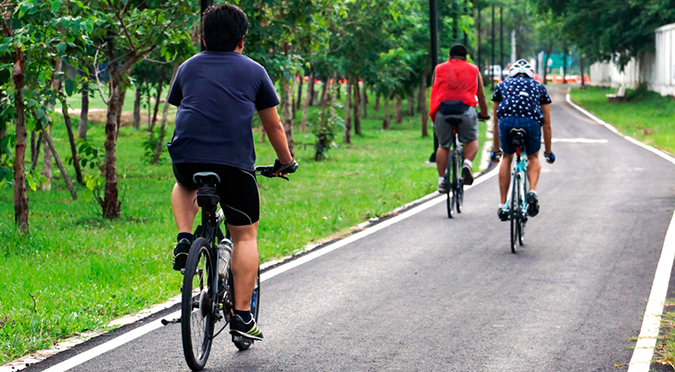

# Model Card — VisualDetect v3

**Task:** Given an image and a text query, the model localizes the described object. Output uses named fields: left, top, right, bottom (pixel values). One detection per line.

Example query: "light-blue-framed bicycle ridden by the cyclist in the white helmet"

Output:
left=506, top=128, right=528, bottom=253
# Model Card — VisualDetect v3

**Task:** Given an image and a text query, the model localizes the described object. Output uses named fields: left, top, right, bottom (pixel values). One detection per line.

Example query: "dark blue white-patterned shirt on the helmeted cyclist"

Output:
left=492, top=77, right=551, bottom=125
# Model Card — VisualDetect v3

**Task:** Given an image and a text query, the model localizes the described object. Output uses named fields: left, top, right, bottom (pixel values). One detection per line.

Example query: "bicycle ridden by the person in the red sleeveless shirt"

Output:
left=445, top=118, right=464, bottom=218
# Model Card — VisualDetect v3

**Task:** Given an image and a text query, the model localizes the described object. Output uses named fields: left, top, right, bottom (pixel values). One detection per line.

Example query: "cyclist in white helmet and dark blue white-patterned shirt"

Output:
left=491, top=59, right=555, bottom=221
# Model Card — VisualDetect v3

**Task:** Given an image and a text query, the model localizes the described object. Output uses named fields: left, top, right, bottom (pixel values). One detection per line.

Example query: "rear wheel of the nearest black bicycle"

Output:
left=181, top=238, right=217, bottom=371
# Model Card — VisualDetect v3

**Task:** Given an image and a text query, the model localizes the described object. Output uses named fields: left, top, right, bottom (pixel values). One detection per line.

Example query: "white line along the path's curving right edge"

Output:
left=566, top=93, right=675, bottom=372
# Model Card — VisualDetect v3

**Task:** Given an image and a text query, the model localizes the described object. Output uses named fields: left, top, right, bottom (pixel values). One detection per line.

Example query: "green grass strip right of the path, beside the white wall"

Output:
left=571, top=87, right=675, bottom=153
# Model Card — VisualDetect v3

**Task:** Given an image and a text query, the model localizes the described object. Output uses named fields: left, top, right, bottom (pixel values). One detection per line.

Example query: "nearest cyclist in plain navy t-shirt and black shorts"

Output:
left=167, top=4, right=297, bottom=340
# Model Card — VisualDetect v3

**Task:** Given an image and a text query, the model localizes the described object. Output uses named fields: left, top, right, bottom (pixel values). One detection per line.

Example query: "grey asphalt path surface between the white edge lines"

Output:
left=35, top=85, right=675, bottom=372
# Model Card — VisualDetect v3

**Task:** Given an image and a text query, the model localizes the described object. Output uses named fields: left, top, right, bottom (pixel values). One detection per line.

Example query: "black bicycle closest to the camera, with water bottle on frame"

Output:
left=177, top=166, right=287, bottom=371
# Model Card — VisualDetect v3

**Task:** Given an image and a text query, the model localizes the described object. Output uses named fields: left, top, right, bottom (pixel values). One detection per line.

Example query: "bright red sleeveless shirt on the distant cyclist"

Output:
left=429, top=59, right=478, bottom=120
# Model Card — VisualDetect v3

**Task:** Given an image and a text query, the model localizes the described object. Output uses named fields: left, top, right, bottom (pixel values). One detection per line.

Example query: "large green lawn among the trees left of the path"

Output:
left=0, top=84, right=492, bottom=364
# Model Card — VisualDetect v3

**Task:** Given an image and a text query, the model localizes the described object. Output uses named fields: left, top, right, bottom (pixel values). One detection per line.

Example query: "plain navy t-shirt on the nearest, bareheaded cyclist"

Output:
left=167, top=51, right=279, bottom=171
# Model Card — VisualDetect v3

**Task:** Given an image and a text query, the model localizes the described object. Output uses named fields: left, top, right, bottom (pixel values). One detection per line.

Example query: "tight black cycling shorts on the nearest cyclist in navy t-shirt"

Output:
left=173, top=163, right=260, bottom=226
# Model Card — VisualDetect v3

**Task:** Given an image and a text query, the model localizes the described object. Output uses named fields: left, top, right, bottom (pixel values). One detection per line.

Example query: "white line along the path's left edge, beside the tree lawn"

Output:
left=43, top=167, right=499, bottom=372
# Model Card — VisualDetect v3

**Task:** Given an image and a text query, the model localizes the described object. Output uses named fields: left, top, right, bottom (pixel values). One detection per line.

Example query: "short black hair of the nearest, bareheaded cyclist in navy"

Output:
left=202, top=4, right=248, bottom=52
